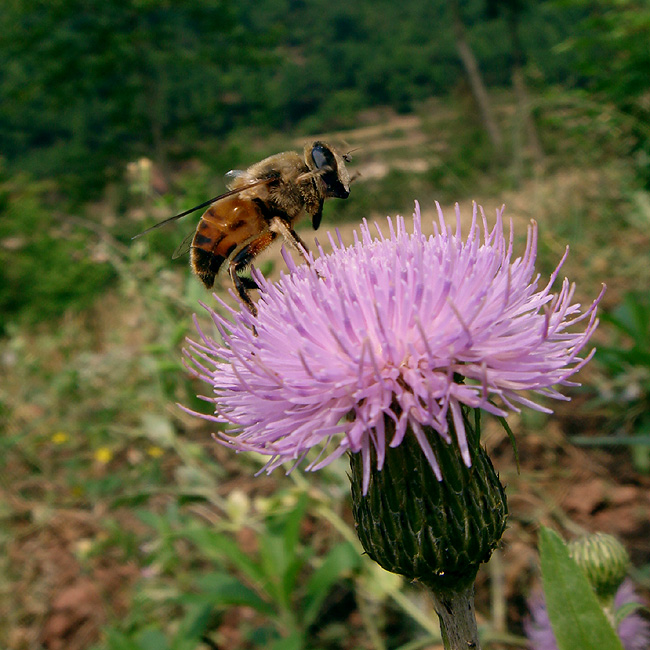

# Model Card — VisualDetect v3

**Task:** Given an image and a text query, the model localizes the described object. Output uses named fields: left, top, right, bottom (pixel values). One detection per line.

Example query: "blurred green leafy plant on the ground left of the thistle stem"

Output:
left=97, top=491, right=362, bottom=650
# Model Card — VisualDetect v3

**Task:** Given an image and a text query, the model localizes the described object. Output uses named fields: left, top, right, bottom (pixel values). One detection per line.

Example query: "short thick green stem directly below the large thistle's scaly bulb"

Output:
left=431, top=584, right=481, bottom=650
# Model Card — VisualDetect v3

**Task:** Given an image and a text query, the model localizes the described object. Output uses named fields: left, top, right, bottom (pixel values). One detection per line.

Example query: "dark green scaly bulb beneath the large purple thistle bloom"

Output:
left=351, top=409, right=508, bottom=591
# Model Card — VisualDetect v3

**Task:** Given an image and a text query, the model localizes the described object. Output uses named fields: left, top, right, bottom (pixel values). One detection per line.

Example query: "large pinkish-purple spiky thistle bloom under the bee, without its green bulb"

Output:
left=186, top=203, right=604, bottom=493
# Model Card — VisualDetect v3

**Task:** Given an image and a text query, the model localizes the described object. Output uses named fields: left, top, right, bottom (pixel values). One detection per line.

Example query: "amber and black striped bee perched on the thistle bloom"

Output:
left=133, top=140, right=350, bottom=315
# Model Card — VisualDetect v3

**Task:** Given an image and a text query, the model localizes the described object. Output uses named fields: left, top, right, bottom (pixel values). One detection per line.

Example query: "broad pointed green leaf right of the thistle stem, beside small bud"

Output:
left=539, top=528, right=623, bottom=650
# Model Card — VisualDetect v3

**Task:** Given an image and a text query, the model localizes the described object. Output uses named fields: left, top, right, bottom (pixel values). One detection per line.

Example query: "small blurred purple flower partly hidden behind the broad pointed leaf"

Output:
left=524, top=579, right=650, bottom=650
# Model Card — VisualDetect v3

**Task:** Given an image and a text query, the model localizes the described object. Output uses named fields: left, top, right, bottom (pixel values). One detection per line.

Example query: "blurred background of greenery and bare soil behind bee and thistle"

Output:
left=0, top=0, right=650, bottom=650
